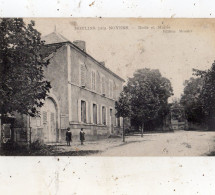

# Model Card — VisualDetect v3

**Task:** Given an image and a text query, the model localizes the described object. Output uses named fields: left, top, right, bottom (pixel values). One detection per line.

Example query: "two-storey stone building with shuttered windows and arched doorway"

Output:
left=29, top=32, right=124, bottom=142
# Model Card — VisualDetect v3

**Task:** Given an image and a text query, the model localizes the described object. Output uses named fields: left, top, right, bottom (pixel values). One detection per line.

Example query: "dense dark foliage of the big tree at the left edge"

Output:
left=0, top=18, right=51, bottom=116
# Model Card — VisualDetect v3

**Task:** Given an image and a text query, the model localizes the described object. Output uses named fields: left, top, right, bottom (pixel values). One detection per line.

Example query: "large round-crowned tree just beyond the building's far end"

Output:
left=116, top=68, right=173, bottom=134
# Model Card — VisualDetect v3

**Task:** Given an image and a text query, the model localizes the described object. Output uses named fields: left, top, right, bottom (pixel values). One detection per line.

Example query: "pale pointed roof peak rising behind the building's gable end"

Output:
left=42, top=31, right=69, bottom=44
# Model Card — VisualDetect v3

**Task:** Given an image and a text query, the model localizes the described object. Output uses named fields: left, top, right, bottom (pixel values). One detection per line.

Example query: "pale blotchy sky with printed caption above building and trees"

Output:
left=25, top=18, right=215, bottom=98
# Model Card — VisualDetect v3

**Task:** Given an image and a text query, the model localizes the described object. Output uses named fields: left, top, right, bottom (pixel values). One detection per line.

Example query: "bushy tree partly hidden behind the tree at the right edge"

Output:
left=180, top=77, right=205, bottom=124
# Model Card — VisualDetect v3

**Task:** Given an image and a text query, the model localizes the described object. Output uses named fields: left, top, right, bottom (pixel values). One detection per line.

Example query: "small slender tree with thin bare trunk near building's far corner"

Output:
left=115, top=91, right=131, bottom=142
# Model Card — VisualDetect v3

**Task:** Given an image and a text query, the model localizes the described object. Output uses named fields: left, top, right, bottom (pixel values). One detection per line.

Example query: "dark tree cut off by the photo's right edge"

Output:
left=194, top=61, right=215, bottom=130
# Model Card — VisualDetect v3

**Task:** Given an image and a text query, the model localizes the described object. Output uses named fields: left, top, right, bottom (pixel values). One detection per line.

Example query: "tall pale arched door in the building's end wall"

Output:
left=41, top=98, right=57, bottom=142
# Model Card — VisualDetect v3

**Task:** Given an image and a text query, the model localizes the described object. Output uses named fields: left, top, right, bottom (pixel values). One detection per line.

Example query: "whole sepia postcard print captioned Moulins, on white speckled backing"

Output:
left=0, top=17, right=215, bottom=157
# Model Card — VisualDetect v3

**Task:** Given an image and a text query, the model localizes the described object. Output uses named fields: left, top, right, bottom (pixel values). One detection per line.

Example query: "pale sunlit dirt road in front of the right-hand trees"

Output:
left=94, top=131, right=215, bottom=156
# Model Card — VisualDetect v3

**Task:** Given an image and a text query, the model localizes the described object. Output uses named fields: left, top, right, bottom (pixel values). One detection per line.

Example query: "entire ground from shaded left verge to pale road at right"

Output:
left=2, top=130, right=215, bottom=156
